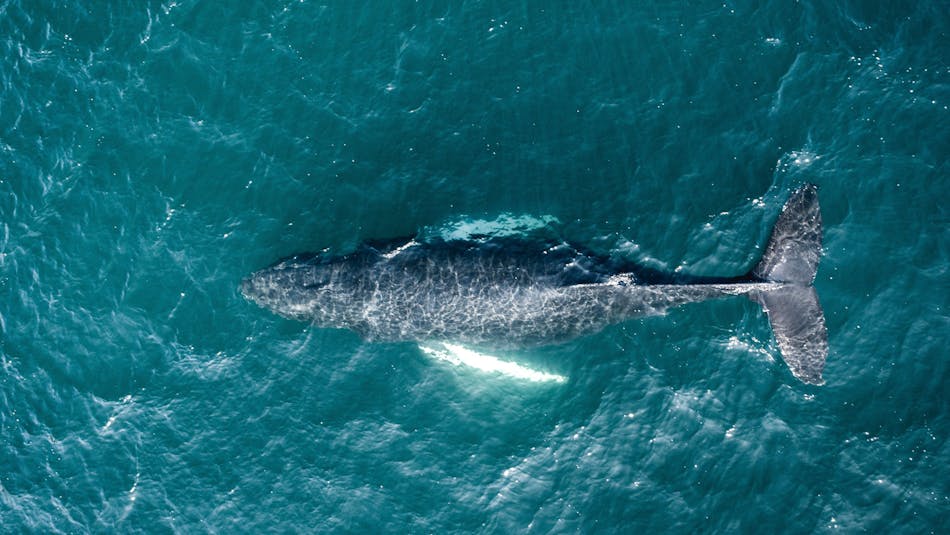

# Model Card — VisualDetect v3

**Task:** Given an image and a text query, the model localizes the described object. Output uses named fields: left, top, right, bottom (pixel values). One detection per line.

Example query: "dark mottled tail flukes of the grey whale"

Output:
left=749, top=184, right=828, bottom=385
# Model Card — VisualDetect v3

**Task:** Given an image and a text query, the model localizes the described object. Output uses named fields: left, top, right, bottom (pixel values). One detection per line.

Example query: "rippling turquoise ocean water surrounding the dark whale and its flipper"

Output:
left=0, top=0, right=950, bottom=533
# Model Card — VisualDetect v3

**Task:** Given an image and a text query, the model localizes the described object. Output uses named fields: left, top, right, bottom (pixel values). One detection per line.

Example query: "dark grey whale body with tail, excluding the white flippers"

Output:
left=241, top=184, right=828, bottom=385
